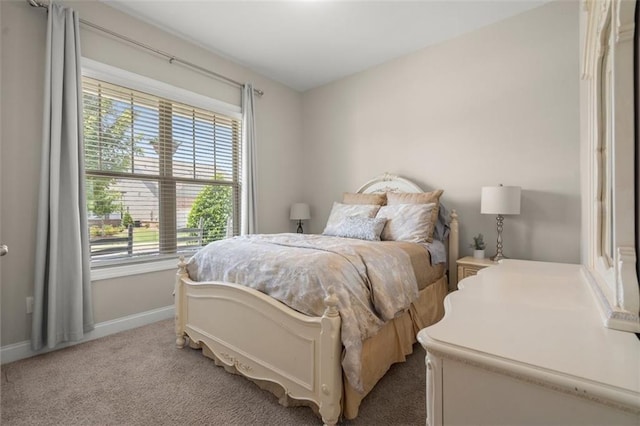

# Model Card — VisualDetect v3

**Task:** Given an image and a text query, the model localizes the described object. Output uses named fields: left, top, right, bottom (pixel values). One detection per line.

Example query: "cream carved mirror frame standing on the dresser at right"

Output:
left=581, top=0, right=640, bottom=333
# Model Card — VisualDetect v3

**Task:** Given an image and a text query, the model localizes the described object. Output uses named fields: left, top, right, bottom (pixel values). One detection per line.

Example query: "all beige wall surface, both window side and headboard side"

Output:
left=0, top=0, right=580, bottom=346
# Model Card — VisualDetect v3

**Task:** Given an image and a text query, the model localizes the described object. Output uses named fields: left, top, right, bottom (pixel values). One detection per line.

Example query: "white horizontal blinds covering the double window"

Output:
left=83, top=77, right=241, bottom=260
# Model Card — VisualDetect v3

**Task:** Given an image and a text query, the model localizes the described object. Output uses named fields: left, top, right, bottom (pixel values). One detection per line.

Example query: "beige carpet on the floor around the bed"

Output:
left=0, top=320, right=425, bottom=425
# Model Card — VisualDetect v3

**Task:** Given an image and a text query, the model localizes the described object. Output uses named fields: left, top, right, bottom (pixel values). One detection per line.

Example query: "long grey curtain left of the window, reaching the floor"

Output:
left=31, top=3, right=93, bottom=350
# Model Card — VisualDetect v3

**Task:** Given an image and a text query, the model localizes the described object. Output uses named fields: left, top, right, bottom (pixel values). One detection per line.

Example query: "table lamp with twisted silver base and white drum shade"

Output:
left=480, top=185, right=521, bottom=262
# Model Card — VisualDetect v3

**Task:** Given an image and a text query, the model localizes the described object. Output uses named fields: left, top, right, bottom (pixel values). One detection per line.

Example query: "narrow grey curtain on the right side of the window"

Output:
left=240, top=84, right=258, bottom=235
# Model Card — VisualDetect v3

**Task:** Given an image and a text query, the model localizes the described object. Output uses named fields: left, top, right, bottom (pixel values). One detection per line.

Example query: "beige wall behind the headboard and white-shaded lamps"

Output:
left=303, top=1, right=580, bottom=263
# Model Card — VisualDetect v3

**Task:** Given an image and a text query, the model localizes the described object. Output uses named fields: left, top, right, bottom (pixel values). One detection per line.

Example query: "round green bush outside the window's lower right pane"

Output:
left=187, top=185, right=233, bottom=244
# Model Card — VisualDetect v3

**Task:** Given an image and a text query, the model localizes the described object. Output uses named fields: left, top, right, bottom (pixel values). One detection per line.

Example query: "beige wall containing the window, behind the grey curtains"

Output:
left=0, top=0, right=302, bottom=347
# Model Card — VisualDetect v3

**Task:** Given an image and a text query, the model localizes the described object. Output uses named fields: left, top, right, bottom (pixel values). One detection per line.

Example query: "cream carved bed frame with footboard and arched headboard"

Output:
left=175, top=173, right=458, bottom=425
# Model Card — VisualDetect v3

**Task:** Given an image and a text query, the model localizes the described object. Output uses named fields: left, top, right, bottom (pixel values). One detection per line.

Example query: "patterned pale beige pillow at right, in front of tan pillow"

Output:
left=376, top=203, right=436, bottom=243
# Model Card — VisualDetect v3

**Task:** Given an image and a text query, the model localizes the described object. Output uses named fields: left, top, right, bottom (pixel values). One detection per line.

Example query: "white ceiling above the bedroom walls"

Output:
left=102, top=0, right=549, bottom=91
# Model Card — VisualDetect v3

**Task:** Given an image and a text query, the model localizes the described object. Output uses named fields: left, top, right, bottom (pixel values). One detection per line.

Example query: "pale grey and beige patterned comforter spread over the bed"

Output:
left=187, top=234, right=418, bottom=391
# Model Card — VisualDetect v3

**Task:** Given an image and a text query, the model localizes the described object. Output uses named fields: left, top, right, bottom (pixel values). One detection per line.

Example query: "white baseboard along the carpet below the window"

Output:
left=0, top=305, right=174, bottom=364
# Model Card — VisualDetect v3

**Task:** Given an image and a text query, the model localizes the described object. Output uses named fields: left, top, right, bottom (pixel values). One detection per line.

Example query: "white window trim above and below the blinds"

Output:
left=82, top=57, right=242, bottom=281
